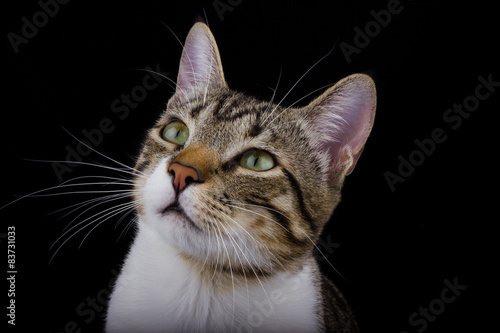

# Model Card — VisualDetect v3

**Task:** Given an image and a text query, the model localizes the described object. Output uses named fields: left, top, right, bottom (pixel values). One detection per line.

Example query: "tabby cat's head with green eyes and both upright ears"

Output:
left=135, top=23, right=376, bottom=275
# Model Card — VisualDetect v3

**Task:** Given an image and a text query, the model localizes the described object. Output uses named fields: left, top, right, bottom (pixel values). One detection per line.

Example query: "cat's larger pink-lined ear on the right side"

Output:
left=307, top=74, right=377, bottom=175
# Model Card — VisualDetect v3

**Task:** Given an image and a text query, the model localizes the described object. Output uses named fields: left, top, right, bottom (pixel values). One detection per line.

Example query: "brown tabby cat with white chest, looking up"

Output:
left=106, top=22, right=376, bottom=333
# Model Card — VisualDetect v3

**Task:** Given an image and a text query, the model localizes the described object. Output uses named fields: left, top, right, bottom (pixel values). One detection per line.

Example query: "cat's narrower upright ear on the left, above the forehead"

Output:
left=176, top=22, right=226, bottom=96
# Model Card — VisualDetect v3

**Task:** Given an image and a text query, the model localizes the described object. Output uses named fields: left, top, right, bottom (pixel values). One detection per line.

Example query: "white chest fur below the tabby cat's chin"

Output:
left=106, top=226, right=321, bottom=333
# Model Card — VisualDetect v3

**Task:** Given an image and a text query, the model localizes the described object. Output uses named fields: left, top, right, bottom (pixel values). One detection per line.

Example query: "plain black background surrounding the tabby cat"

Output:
left=0, top=0, right=500, bottom=333
